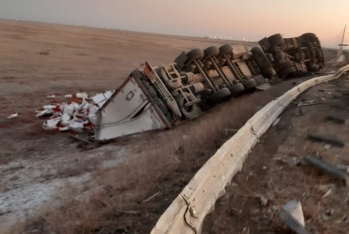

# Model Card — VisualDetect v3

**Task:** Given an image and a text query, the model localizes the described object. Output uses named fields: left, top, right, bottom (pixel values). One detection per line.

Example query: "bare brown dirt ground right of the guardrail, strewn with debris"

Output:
left=203, top=77, right=349, bottom=234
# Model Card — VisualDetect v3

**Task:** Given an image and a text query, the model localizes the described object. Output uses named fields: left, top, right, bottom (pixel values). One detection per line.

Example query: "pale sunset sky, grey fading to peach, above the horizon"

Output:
left=0, top=0, right=349, bottom=46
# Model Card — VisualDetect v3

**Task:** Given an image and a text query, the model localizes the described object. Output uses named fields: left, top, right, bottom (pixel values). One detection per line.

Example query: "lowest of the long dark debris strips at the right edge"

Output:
left=305, top=156, right=349, bottom=186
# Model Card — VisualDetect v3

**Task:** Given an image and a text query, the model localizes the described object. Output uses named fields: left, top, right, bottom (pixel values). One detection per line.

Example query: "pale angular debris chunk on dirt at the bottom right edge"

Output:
left=279, top=200, right=311, bottom=234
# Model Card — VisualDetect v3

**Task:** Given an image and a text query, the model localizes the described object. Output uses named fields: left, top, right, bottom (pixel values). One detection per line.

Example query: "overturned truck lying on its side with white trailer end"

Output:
left=94, top=33, right=324, bottom=141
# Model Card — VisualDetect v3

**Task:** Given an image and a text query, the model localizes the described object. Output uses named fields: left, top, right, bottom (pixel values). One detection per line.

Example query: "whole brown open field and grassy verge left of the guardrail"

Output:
left=0, top=21, right=338, bottom=233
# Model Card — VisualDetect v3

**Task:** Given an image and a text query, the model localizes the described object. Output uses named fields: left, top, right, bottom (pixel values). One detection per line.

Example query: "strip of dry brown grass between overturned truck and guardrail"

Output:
left=8, top=87, right=290, bottom=234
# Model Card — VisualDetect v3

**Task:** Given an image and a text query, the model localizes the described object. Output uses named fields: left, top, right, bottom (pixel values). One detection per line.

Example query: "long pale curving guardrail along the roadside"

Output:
left=151, top=65, right=349, bottom=234
